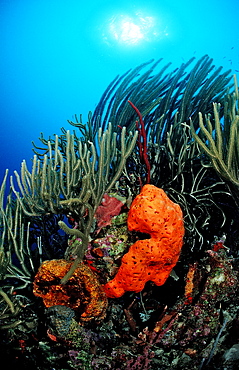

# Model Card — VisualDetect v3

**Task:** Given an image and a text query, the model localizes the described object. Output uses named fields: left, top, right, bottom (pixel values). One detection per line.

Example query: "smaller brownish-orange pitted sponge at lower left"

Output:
left=33, top=259, right=107, bottom=321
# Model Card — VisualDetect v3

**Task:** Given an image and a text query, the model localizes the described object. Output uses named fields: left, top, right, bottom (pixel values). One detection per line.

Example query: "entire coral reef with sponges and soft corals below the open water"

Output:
left=0, top=55, right=239, bottom=370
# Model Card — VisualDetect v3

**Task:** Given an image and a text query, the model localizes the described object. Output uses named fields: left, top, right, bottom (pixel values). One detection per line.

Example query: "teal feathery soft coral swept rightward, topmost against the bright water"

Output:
left=69, top=55, right=231, bottom=158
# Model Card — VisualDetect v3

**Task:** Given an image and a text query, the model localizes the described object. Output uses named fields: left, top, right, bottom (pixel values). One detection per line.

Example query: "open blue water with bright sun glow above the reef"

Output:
left=0, top=0, right=239, bottom=181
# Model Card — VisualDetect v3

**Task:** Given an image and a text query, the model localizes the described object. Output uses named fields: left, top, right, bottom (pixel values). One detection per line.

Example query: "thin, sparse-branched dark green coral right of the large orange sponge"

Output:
left=149, top=115, right=232, bottom=250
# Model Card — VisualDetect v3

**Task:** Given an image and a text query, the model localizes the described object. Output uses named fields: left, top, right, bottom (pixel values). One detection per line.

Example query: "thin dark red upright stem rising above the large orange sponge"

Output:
left=128, top=100, right=151, bottom=184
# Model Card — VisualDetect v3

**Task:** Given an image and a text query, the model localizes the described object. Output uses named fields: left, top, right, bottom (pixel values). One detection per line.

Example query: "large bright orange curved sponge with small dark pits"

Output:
left=104, top=184, right=184, bottom=298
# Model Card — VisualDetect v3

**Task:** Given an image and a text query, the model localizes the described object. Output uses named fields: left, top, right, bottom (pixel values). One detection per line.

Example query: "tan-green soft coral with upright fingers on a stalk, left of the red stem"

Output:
left=11, top=124, right=138, bottom=283
